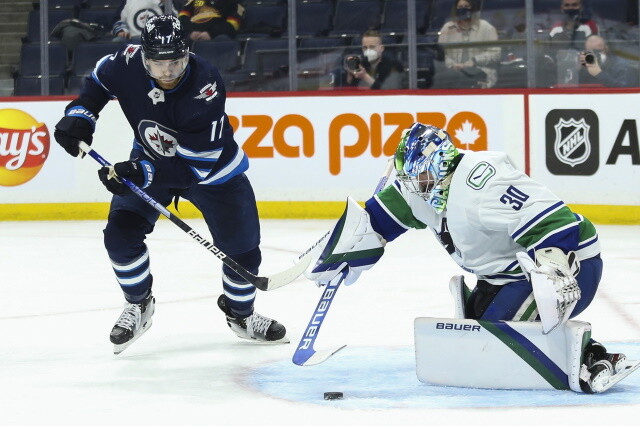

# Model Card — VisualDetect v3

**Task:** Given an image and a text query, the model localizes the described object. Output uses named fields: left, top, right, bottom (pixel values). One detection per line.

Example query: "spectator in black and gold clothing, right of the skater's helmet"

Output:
left=178, top=0, right=244, bottom=41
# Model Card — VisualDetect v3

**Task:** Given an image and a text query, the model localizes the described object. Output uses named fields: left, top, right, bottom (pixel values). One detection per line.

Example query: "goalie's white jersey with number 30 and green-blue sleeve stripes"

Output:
left=366, top=150, right=600, bottom=285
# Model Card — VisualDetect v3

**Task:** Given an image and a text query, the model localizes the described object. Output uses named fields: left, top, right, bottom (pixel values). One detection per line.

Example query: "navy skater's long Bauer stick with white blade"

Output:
left=80, top=142, right=310, bottom=291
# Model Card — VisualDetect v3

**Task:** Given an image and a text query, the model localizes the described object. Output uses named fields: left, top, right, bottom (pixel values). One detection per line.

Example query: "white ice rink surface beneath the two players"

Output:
left=0, top=220, right=640, bottom=426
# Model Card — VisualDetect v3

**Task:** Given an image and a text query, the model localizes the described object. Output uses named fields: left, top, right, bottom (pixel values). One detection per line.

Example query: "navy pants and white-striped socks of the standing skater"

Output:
left=104, top=174, right=262, bottom=317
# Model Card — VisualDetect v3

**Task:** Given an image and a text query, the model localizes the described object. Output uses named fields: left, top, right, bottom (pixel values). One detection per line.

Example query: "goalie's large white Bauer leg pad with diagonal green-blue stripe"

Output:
left=414, top=317, right=591, bottom=392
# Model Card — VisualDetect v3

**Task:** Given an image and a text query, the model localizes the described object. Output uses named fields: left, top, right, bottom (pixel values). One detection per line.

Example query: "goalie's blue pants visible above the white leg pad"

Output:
left=465, top=256, right=602, bottom=321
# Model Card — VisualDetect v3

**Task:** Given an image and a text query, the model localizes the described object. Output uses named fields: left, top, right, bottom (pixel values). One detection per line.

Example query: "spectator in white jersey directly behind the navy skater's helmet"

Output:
left=112, top=0, right=177, bottom=43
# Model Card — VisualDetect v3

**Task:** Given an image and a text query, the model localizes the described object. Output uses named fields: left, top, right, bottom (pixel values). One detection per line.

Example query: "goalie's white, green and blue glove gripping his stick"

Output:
left=304, top=197, right=387, bottom=286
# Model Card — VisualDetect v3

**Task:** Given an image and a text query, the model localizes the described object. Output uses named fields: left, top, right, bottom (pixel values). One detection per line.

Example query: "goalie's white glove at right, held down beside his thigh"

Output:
left=516, top=247, right=581, bottom=334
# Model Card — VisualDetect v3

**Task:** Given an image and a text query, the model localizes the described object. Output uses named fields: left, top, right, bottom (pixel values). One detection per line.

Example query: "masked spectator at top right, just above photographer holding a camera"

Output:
left=549, top=0, right=598, bottom=50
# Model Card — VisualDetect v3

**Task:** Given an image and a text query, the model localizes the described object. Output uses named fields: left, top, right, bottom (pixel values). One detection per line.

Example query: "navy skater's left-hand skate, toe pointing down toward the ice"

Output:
left=109, top=293, right=156, bottom=355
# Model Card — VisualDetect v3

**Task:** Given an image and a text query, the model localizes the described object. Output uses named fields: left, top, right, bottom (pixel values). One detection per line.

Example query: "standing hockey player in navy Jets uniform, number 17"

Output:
left=54, top=15, right=288, bottom=353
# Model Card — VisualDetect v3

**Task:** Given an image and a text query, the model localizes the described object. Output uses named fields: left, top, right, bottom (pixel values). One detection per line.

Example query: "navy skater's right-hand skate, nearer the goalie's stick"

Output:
left=218, top=294, right=289, bottom=343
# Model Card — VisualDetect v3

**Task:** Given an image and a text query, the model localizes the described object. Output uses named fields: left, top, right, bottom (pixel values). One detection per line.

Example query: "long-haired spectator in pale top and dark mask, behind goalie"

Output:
left=433, top=0, right=501, bottom=88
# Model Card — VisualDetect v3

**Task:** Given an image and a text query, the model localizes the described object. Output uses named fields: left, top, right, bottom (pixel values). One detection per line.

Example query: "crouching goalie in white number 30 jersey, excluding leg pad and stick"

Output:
left=305, top=123, right=628, bottom=393
